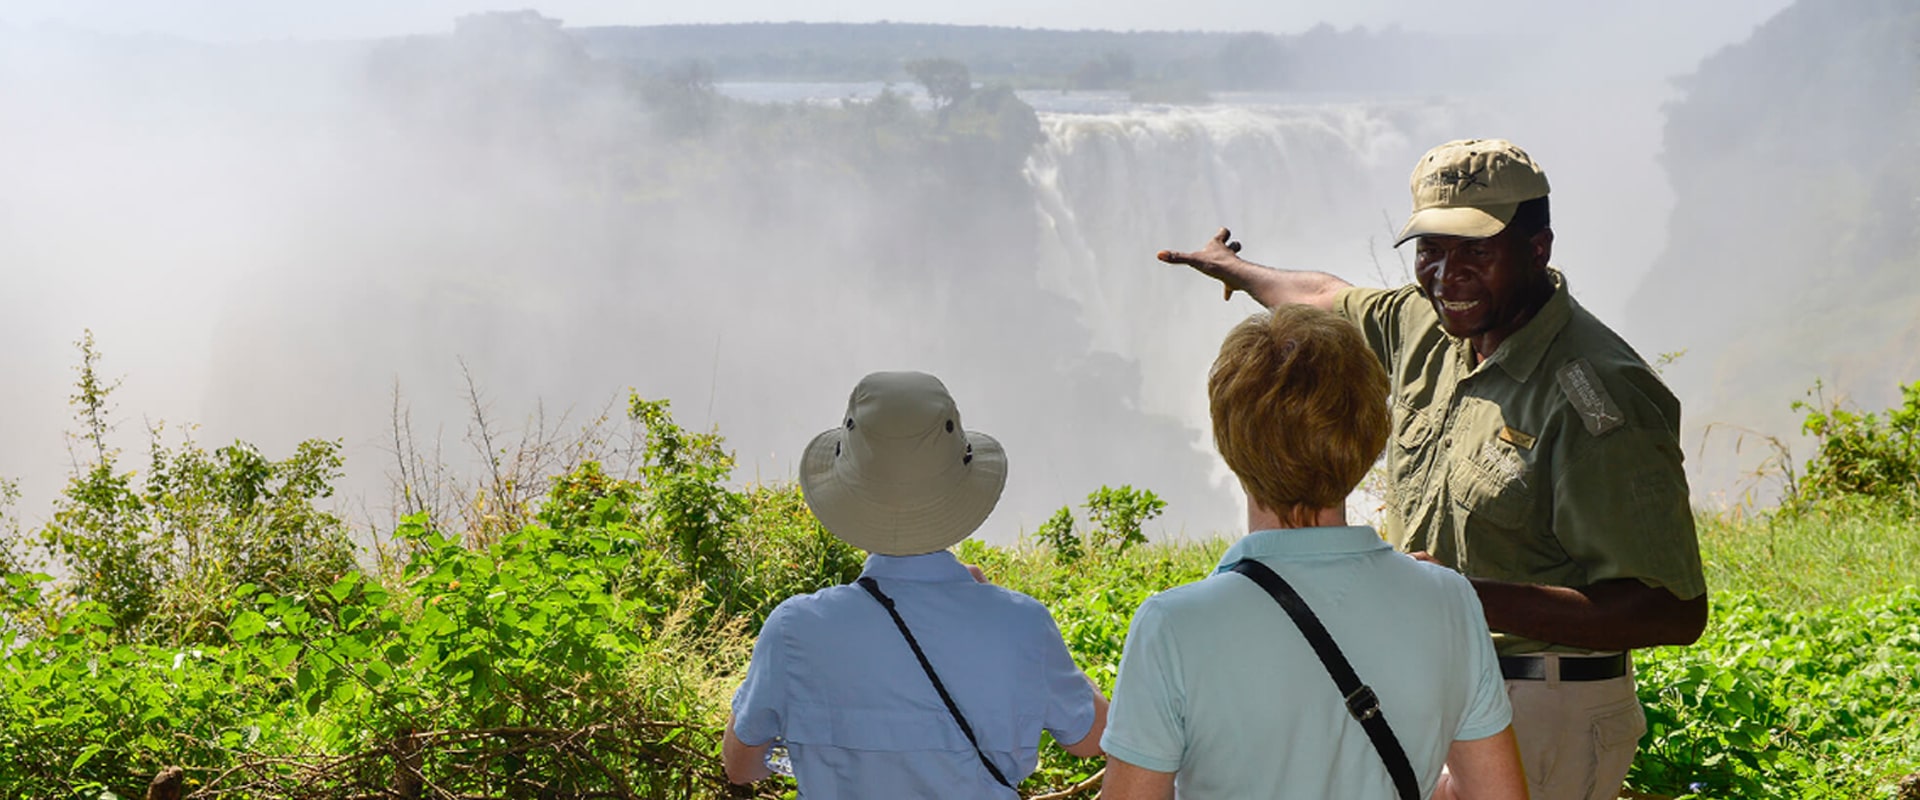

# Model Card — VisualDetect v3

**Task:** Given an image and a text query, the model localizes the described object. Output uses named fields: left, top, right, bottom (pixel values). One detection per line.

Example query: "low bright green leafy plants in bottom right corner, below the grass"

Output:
left=1628, top=587, right=1920, bottom=798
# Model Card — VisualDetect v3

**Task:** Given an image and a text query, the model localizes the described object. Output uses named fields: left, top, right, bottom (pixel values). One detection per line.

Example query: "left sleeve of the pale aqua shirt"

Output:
left=1100, top=597, right=1187, bottom=773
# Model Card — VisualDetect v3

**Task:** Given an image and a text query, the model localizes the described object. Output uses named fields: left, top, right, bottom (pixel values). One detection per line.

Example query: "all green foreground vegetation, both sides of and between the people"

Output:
left=0, top=338, right=1920, bottom=798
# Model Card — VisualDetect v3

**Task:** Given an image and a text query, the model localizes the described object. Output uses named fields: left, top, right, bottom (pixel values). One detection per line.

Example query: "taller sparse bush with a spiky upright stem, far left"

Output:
left=38, top=334, right=353, bottom=643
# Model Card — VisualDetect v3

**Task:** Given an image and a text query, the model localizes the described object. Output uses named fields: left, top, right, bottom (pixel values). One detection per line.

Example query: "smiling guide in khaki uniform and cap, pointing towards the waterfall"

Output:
left=1160, top=140, right=1707, bottom=800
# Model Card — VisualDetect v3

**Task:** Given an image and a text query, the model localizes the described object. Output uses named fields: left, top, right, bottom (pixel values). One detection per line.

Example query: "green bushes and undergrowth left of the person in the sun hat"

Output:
left=0, top=338, right=860, bottom=798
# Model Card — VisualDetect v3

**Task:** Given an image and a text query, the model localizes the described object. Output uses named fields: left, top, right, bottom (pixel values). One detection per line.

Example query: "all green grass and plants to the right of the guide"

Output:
left=1630, top=384, right=1920, bottom=798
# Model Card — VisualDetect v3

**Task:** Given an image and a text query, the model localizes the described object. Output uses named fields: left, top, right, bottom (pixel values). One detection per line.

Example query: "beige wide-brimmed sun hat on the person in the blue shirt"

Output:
left=801, top=372, right=1006, bottom=556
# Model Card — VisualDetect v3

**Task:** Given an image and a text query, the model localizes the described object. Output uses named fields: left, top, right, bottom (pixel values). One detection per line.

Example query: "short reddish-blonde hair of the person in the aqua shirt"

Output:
left=1206, top=305, right=1392, bottom=522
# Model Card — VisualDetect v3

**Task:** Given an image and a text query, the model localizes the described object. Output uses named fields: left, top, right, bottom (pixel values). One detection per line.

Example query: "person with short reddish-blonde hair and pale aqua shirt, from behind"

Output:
left=1100, top=305, right=1526, bottom=800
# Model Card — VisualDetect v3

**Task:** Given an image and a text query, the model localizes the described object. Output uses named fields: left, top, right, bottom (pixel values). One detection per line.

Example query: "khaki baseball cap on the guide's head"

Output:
left=1394, top=138, right=1549, bottom=247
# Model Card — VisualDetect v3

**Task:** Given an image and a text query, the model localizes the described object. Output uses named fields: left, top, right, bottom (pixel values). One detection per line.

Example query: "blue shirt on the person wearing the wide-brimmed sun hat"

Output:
left=733, top=551, right=1092, bottom=800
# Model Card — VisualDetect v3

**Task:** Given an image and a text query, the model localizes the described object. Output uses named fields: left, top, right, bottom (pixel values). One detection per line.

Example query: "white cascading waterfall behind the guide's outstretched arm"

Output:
left=1027, top=102, right=1452, bottom=531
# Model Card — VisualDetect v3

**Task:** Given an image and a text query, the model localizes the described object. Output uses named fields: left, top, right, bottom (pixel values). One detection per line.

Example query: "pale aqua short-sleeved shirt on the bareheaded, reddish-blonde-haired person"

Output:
left=1100, top=528, right=1513, bottom=800
